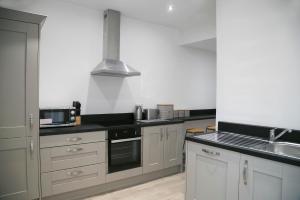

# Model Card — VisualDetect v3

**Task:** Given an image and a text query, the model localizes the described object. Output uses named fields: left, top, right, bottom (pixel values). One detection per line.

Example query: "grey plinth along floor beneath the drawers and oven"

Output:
left=42, top=166, right=181, bottom=200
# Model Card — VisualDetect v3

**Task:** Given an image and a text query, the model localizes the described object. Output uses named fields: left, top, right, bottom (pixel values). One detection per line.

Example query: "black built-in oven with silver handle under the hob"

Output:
left=108, top=127, right=141, bottom=173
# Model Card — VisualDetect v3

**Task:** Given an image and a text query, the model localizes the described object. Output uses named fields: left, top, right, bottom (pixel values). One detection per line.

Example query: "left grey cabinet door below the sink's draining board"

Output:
left=186, top=142, right=240, bottom=200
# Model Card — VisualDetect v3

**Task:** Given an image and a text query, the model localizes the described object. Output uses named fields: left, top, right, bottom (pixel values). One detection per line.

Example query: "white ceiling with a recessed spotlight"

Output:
left=64, top=0, right=216, bottom=29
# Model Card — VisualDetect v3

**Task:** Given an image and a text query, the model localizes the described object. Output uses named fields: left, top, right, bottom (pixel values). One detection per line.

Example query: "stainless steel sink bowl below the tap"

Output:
left=258, top=142, right=300, bottom=158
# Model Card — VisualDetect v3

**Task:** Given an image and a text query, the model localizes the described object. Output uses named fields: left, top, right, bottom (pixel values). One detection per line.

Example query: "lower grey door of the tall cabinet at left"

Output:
left=0, top=137, right=39, bottom=199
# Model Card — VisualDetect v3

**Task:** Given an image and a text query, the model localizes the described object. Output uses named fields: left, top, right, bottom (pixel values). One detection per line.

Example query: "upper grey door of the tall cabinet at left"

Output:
left=0, top=19, right=39, bottom=138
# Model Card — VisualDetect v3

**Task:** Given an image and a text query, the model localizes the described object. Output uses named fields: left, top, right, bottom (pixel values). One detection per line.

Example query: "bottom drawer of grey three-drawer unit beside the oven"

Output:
left=42, top=164, right=105, bottom=197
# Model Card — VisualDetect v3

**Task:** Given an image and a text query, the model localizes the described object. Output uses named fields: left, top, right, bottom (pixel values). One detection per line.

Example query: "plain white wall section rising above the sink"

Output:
left=217, top=0, right=300, bottom=129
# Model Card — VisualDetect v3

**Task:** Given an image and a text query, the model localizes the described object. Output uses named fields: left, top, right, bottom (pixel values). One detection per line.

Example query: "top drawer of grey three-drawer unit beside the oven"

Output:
left=40, top=131, right=105, bottom=148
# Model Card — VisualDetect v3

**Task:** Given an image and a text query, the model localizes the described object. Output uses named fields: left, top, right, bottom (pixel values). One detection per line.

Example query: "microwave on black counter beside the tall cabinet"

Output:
left=40, top=107, right=76, bottom=128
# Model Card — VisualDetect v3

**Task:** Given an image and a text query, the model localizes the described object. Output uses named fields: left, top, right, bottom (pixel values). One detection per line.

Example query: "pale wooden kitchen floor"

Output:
left=85, top=174, right=185, bottom=200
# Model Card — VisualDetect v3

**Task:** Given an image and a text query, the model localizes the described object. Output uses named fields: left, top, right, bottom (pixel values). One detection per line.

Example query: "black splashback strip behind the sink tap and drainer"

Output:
left=218, top=121, right=300, bottom=143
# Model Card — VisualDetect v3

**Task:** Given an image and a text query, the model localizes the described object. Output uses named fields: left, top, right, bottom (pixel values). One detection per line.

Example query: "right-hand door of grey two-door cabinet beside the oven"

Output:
left=164, top=125, right=182, bottom=168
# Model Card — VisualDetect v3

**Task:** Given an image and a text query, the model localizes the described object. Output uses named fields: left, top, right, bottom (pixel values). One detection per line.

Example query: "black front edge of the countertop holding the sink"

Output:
left=185, top=136, right=300, bottom=166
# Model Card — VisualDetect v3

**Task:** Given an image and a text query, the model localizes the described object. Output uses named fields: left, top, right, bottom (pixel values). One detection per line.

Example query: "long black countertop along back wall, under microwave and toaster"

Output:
left=40, top=115, right=216, bottom=136
